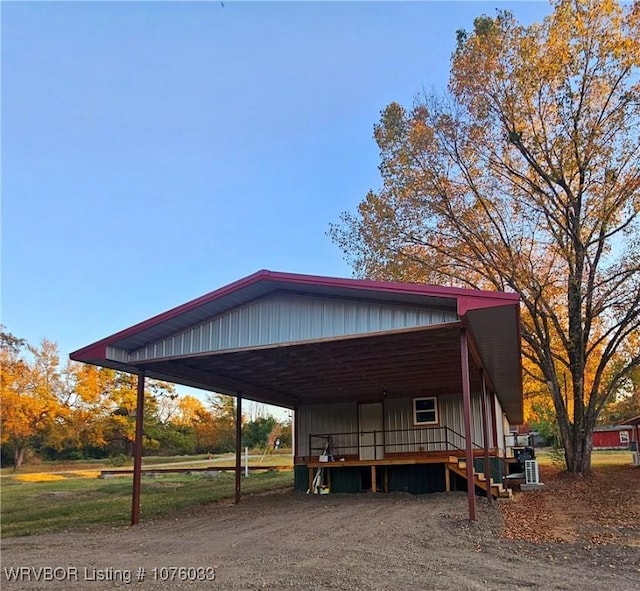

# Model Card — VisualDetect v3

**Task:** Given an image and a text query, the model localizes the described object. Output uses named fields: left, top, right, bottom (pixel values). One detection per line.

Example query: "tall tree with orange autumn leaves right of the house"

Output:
left=331, top=0, right=640, bottom=473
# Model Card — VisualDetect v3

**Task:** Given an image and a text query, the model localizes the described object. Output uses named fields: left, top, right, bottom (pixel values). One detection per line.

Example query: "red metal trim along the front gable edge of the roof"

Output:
left=70, top=269, right=520, bottom=361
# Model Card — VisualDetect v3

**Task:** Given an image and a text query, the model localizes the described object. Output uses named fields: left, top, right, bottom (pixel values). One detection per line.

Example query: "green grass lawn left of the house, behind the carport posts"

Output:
left=0, top=468, right=293, bottom=536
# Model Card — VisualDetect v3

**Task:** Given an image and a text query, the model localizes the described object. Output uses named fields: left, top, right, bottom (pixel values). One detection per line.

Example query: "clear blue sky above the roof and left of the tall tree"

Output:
left=1, top=1, right=550, bottom=366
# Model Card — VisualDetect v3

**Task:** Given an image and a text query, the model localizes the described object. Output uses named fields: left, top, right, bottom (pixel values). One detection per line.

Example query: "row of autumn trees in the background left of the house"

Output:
left=0, top=331, right=291, bottom=469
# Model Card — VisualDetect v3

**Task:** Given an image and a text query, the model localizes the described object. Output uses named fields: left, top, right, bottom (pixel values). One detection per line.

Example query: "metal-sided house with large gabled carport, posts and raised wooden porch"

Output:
left=71, top=271, right=523, bottom=523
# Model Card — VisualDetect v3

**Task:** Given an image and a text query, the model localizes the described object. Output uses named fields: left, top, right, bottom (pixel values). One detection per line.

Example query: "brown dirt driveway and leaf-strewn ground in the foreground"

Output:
left=0, top=467, right=640, bottom=591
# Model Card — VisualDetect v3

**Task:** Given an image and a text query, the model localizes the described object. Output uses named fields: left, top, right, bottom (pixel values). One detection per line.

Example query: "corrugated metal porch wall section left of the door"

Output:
left=296, top=402, right=358, bottom=456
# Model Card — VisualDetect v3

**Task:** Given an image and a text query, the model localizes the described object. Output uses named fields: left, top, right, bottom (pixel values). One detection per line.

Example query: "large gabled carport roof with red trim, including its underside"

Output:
left=71, top=271, right=522, bottom=423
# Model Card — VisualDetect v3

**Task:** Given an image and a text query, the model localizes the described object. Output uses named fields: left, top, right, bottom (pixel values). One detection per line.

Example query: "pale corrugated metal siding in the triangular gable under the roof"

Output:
left=129, top=294, right=458, bottom=363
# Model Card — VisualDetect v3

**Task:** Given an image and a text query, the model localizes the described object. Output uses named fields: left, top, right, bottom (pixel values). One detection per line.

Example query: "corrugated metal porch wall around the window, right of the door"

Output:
left=384, top=396, right=482, bottom=453
